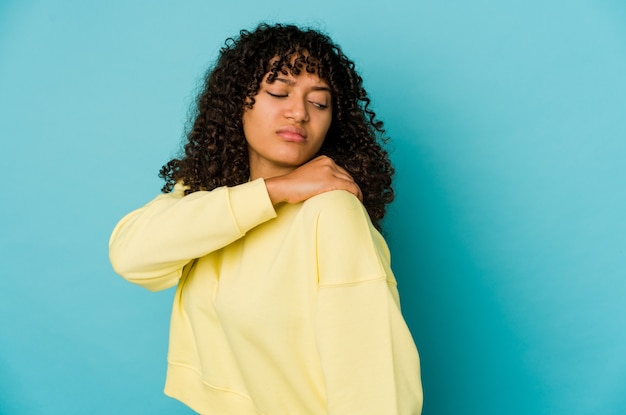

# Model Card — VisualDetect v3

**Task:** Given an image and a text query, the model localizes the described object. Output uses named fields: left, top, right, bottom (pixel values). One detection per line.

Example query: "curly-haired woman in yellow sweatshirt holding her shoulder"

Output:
left=110, top=24, right=422, bottom=415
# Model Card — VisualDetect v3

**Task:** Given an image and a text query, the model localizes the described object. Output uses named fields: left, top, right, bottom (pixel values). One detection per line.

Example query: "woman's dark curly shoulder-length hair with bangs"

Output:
left=159, top=23, right=394, bottom=229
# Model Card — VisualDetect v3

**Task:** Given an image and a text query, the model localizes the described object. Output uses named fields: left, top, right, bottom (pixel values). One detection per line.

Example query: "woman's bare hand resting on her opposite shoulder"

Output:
left=265, top=156, right=363, bottom=205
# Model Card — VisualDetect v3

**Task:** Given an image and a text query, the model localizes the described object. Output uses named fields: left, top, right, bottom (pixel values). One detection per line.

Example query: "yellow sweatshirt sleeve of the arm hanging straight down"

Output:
left=316, top=192, right=422, bottom=415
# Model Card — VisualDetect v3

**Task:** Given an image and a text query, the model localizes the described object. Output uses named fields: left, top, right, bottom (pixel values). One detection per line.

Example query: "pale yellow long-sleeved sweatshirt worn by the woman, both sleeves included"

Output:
left=110, top=179, right=422, bottom=415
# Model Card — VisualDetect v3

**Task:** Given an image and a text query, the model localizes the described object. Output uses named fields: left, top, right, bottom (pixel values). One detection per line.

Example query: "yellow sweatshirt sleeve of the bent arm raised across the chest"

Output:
left=109, top=179, right=276, bottom=291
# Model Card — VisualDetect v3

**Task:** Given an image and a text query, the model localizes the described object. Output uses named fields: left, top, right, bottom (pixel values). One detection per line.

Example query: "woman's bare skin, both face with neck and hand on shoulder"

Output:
left=243, top=73, right=362, bottom=204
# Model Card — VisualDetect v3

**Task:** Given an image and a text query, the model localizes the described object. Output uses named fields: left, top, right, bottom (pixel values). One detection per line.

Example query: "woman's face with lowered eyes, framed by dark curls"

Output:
left=243, top=69, right=332, bottom=179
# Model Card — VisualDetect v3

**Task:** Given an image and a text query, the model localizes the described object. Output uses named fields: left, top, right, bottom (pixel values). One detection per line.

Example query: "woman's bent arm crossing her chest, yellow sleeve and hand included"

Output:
left=109, top=156, right=361, bottom=291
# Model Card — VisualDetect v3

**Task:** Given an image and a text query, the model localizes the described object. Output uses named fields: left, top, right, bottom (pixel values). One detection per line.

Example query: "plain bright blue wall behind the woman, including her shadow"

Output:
left=0, top=0, right=626, bottom=415
